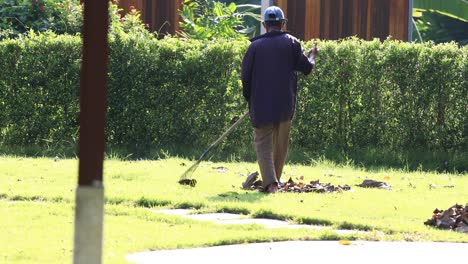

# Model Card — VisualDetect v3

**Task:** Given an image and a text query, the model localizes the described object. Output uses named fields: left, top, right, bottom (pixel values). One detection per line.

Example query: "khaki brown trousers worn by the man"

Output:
left=254, top=120, right=291, bottom=188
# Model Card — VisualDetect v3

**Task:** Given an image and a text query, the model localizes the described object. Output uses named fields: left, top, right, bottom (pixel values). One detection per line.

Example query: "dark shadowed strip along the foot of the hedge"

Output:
left=0, top=142, right=468, bottom=173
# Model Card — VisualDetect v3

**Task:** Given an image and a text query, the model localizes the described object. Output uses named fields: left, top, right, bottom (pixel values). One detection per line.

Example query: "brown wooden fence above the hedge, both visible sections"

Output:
left=119, top=0, right=411, bottom=41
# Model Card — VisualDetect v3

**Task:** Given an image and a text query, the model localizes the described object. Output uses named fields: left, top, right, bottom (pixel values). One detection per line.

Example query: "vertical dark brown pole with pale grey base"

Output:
left=73, top=0, right=109, bottom=264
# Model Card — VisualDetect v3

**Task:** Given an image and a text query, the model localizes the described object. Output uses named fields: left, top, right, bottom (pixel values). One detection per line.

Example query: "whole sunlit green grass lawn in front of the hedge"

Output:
left=0, top=157, right=468, bottom=263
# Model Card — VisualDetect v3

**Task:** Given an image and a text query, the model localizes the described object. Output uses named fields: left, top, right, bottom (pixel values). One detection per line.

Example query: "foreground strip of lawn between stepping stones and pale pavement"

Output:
left=0, top=200, right=354, bottom=264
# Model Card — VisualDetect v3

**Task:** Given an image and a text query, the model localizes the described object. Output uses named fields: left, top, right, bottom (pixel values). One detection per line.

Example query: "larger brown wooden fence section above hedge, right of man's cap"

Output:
left=274, top=0, right=411, bottom=41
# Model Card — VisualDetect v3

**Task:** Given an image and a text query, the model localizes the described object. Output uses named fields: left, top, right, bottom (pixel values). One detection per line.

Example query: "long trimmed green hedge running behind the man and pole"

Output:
left=0, top=35, right=468, bottom=157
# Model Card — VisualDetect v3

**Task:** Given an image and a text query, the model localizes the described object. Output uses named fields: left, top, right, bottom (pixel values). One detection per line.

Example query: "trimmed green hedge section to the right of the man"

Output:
left=293, top=39, right=468, bottom=153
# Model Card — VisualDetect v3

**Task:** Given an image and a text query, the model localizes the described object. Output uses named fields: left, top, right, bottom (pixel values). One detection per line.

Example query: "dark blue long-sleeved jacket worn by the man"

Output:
left=241, top=31, right=313, bottom=127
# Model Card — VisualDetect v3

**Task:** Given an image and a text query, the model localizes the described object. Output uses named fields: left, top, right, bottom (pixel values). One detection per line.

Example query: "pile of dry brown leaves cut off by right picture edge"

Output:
left=424, top=204, right=468, bottom=233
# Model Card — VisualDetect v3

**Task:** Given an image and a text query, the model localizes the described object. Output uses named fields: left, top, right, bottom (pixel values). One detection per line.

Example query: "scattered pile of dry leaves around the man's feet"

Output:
left=242, top=172, right=351, bottom=193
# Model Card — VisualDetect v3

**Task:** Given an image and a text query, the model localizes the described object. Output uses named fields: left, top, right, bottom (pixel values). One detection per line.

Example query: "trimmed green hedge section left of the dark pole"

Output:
left=0, top=34, right=81, bottom=145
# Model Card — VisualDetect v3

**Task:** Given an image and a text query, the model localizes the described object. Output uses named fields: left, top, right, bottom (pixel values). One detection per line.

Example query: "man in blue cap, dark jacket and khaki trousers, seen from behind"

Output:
left=241, top=6, right=318, bottom=193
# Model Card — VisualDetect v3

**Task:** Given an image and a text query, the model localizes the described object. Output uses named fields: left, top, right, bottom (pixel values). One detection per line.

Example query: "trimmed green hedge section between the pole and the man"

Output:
left=108, top=36, right=249, bottom=151
